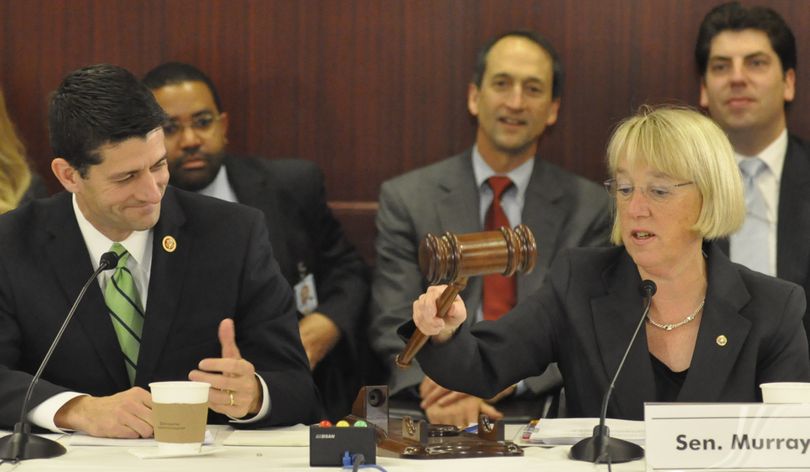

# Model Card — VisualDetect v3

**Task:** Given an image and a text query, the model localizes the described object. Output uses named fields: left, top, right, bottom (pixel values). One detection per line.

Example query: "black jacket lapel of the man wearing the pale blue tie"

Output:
left=776, top=138, right=810, bottom=285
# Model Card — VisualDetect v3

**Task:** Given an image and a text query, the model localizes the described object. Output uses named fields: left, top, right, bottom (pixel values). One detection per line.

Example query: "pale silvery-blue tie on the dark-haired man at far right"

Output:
left=732, top=157, right=770, bottom=274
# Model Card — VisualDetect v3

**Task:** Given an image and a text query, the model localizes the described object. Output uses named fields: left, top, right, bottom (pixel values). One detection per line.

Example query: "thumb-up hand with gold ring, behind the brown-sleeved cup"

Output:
left=188, top=318, right=262, bottom=418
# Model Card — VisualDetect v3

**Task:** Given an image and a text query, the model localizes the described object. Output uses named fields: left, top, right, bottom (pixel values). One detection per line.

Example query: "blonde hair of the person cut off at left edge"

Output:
left=0, top=90, right=31, bottom=214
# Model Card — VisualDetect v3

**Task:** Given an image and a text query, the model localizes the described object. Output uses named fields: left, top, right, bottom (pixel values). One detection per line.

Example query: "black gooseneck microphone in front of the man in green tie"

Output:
left=0, top=251, right=118, bottom=462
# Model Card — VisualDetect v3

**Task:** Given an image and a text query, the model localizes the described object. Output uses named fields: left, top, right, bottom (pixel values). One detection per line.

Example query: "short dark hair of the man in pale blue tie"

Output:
left=695, top=2, right=796, bottom=76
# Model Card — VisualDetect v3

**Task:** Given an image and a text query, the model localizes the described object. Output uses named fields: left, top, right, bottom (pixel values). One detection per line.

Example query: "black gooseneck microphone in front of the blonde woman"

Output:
left=569, top=280, right=657, bottom=464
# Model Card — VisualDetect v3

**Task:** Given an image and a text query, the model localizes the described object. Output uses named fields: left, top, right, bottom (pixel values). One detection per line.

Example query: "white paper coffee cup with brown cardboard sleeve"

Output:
left=149, top=381, right=211, bottom=454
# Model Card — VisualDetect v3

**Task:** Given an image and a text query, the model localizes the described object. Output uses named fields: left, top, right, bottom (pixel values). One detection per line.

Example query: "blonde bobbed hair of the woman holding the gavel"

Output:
left=607, top=105, right=745, bottom=244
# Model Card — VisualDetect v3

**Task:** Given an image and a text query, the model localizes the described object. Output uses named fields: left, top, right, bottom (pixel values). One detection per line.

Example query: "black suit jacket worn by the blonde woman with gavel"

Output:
left=410, top=245, right=810, bottom=420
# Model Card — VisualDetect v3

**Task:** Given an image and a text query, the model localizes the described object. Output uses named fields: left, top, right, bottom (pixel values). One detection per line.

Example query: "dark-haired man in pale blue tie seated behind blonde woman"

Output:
left=695, top=2, right=810, bottom=342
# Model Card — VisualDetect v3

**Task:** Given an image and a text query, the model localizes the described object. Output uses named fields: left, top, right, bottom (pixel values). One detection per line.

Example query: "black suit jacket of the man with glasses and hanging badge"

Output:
left=225, top=156, right=369, bottom=420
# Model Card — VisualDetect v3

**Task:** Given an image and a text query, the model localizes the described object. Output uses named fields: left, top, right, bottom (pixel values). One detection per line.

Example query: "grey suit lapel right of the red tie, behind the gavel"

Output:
left=518, top=158, right=566, bottom=300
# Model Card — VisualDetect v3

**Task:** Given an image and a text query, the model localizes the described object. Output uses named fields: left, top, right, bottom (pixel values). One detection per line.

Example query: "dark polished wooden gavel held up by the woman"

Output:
left=395, top=225, right=537, bottom=369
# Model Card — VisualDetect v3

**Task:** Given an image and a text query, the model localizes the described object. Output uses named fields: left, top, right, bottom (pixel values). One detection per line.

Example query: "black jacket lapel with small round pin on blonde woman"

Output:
left=678, top=244, right=751, bottom=402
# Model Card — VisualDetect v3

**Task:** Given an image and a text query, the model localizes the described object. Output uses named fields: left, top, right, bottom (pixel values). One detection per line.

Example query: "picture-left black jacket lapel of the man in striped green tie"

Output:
left=45, top=192, right=129, bottom=390
